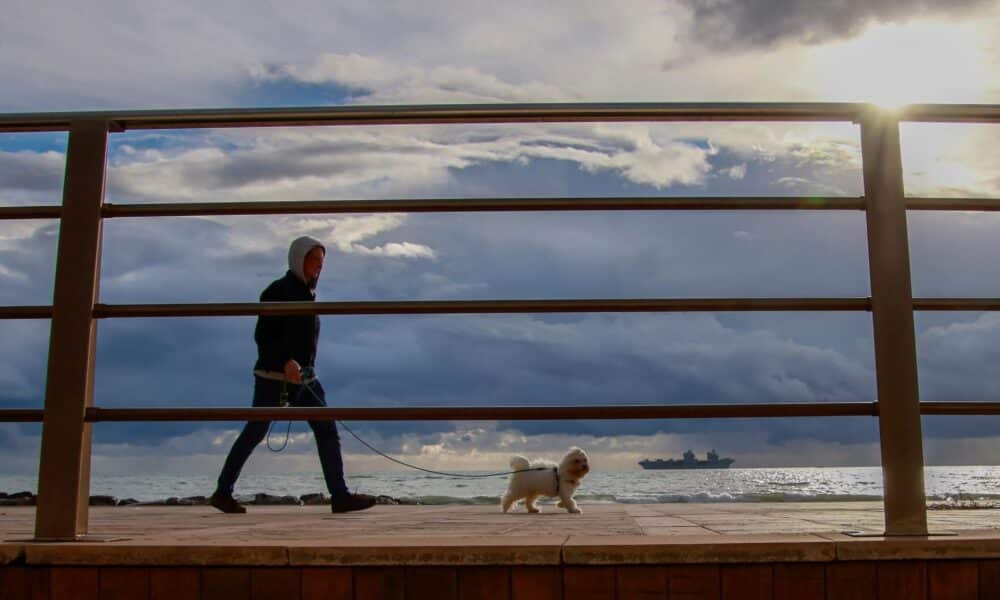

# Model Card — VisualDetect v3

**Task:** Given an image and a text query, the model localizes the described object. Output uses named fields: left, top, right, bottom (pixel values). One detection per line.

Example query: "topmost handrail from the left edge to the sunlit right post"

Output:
left=0, top=102, right=871, bottom=132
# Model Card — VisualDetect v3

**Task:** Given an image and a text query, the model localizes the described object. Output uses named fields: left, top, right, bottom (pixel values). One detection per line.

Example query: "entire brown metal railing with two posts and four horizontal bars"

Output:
left=0, top=103, right=1000, bottom=540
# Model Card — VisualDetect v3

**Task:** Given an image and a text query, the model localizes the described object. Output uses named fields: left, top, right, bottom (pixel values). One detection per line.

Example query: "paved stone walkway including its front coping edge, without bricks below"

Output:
left=0, top=502, right=1000, bottom=565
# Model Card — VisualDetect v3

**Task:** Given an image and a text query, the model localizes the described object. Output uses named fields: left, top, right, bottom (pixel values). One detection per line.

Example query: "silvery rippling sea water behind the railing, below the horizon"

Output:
left=0, top=466, right=1000, bottom=504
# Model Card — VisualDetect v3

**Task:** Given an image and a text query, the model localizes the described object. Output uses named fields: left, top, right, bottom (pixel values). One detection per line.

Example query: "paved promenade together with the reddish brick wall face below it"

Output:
left=0, top=502, right=1000, bottom=600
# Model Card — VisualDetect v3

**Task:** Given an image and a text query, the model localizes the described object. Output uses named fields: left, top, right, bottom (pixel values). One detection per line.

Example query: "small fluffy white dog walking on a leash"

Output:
left=501, top=447, right=590, bottom=514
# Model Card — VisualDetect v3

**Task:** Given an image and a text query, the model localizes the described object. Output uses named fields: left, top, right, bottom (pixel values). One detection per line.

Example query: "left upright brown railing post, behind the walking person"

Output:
left=35, top=121, right=108, bottom=540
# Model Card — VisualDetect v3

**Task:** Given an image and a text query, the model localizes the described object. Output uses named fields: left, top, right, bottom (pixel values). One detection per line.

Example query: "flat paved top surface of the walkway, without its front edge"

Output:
left=0, top=502, right=1000, bottom=543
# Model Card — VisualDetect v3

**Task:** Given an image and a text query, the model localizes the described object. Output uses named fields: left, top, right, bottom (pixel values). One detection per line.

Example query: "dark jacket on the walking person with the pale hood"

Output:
left=253, top=271, right=319, bottom=373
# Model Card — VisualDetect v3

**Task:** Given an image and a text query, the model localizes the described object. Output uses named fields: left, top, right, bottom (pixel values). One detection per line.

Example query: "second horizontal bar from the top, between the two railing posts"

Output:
left=103, top=196, right=865, bottom=218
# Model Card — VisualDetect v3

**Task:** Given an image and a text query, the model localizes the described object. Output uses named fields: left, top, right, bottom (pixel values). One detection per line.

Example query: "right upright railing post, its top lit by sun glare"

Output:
left=861, top=108, right=927, bottom=535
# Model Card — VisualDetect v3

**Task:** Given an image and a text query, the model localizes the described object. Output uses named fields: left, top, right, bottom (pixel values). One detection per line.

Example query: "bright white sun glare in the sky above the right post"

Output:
left=814, top=21, right=996, bottom=107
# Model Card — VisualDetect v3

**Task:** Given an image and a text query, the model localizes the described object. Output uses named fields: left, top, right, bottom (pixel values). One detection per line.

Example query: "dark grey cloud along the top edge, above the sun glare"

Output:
left=681, top=0, right=992, bottom=50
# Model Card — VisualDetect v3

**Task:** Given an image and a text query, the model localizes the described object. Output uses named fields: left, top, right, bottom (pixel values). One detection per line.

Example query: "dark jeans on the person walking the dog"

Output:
left=216, top=375, right=348, bottom=498
